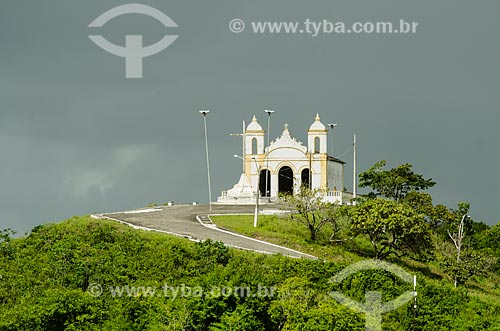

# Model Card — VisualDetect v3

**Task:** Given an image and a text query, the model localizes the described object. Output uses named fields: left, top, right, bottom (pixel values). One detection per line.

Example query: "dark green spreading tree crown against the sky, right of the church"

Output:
left=359, top=160, right=436, bottom=201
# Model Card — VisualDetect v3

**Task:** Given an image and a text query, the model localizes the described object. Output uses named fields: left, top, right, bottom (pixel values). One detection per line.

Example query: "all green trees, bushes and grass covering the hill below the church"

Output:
left=0, top=163, right=500, bottom=331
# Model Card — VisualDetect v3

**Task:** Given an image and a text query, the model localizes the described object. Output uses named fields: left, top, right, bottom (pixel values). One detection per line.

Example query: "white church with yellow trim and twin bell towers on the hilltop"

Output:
left=217, top=114, right=352, bottom=204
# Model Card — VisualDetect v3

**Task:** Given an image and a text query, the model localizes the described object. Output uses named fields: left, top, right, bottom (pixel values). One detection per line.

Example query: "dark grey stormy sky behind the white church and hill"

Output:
left=0, top=0, right=500, bottom=232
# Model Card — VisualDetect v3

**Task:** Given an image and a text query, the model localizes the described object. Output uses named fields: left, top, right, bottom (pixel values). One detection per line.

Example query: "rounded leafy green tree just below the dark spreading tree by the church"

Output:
left=350, top=198, right=432, bottom=260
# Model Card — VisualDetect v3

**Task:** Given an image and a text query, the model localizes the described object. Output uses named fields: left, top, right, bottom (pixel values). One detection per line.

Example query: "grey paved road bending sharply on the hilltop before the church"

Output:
left=94, top=205, right=314, bottom=259
